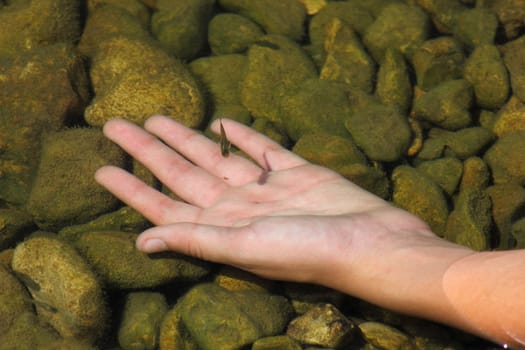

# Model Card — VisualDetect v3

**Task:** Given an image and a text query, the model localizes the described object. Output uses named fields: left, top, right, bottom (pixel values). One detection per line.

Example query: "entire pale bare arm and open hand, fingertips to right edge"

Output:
left=96, top=116, right=525, bottom=348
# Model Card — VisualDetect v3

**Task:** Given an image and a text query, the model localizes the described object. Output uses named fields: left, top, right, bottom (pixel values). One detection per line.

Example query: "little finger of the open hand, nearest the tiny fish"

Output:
left=211, top=119, right=308, bottom=170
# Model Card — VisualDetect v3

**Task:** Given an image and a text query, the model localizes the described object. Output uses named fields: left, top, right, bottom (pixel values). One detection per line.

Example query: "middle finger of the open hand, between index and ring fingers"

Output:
left=104, top=119, right=229, bottom=207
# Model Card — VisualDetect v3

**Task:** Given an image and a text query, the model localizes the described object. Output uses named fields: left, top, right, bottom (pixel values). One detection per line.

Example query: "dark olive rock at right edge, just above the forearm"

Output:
left=486, top=183, right=525, bottom=249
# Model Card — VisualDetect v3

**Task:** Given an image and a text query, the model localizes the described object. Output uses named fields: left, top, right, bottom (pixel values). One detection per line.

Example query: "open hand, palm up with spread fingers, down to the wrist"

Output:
left=96, top=116, right=470, bottom=316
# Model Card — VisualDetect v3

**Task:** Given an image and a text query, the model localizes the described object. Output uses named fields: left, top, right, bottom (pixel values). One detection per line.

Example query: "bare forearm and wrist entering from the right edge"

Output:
left=325, top=232, right=525, bottom=347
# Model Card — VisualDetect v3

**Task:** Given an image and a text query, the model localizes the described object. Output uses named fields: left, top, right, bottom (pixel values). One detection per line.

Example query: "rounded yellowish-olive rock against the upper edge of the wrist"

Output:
left=392, top=165, right=448, bottom=236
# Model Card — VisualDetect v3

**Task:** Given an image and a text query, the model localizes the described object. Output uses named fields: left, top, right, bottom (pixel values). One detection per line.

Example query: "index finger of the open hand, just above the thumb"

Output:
left=95, top=166, right=200, bottom=225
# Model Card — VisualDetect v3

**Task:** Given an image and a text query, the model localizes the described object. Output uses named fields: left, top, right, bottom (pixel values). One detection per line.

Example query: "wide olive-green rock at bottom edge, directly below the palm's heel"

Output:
left=178, top=283, right=292, bottom=350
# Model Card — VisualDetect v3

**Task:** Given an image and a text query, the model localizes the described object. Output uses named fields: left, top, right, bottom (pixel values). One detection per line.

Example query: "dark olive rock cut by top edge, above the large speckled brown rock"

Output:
left=151, top=0, right=215, bottom=60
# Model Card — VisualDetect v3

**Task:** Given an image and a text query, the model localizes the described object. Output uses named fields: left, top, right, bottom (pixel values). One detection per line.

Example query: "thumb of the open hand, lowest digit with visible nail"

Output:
left=136, top=223, right=244, bottom=263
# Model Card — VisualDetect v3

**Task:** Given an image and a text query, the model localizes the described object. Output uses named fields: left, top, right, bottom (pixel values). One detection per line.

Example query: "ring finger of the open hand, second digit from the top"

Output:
left=144, top=116, right=261, bottom=185
